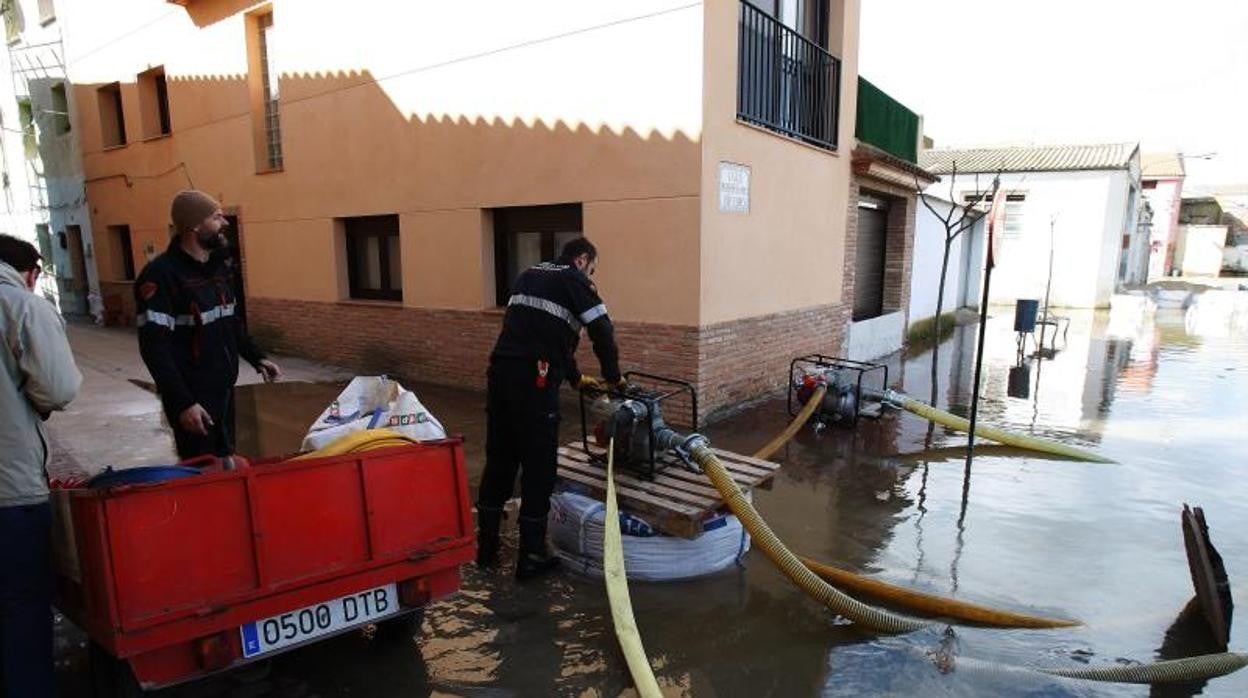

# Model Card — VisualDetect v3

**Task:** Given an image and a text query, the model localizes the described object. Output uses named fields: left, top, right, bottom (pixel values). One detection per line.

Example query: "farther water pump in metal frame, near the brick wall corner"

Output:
left=789, top=353, right=889, bottom=427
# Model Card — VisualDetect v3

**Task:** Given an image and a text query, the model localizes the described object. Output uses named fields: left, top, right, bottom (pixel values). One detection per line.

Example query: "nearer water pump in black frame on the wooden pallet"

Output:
left=580, top=372, right=698, bottom=479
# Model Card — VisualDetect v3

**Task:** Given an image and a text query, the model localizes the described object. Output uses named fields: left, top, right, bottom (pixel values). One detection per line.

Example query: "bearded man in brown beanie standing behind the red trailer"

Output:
left=135, top=190, right=282, bottom=460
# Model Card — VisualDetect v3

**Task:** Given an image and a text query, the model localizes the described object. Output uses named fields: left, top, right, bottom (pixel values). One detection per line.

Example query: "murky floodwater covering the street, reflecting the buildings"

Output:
left=53, top=303, right=1248, bottom=697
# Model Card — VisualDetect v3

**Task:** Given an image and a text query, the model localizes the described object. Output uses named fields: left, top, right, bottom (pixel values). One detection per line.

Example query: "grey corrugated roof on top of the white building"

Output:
left=919, top=142, right=1138, bottom=175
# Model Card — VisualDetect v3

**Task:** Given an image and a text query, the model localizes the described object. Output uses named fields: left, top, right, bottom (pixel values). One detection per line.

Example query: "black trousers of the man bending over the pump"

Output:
left=477, top=360, right=563, bottom=523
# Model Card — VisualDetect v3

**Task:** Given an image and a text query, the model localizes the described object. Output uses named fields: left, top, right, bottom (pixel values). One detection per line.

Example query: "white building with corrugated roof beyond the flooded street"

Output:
left=920, top=144, right=1148, bottom=307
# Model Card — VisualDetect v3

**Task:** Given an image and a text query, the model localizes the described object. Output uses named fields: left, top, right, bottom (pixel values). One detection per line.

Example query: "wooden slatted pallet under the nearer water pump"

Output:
left=559, top=441, right=780, bottom=538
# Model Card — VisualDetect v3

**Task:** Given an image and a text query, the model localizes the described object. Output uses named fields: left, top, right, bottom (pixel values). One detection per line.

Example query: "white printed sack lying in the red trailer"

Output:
left=302, top=376, right=447, bottom=451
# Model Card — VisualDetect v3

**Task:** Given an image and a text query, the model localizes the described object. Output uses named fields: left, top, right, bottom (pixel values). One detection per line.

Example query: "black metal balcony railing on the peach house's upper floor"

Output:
left=736, top=0, right=841, bottom=150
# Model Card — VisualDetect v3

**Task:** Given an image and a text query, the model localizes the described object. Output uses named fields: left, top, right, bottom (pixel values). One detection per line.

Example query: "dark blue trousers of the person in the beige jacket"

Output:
left=0, top=502, right=55, bottom=698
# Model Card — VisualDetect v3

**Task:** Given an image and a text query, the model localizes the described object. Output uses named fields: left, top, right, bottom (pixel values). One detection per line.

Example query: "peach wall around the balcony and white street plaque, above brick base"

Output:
left=700, top=0, right=859, bottom=325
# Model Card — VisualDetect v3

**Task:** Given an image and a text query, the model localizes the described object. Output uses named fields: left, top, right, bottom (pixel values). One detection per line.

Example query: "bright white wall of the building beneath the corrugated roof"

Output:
left=927, top=170, right=1138, bottom=307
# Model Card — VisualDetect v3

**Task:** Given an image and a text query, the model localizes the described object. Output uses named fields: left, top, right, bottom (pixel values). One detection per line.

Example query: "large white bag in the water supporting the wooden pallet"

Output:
left=549, top=492, right=750, bottom=582
